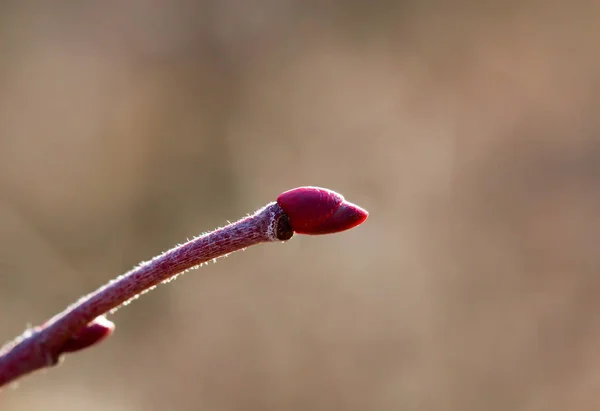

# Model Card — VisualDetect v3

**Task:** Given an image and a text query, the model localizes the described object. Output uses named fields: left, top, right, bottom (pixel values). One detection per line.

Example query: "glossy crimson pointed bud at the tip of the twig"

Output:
left=277, top=187, right=369, bottom=235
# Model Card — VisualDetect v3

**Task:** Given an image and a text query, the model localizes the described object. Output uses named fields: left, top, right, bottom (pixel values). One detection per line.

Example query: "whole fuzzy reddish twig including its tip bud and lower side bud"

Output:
left=0, top=187, right=367, bottom=387
